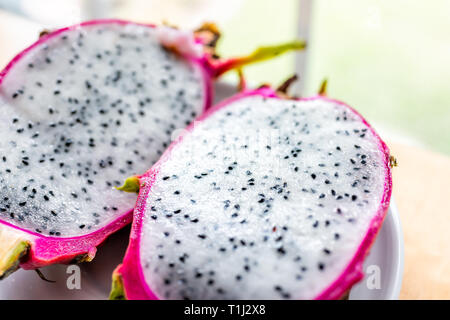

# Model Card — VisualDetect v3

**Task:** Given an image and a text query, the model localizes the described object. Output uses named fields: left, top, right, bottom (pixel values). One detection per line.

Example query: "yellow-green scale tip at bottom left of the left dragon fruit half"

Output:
left=0, top=225, right=30, bottom=280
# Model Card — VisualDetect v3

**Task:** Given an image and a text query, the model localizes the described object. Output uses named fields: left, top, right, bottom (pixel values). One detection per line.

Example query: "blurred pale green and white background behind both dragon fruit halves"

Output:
left=0, top=0, right=450, bottom=154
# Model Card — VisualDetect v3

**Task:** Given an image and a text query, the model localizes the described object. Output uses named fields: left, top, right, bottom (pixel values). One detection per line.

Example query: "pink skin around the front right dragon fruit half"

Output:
left=110, top=86, right=392, bottom=300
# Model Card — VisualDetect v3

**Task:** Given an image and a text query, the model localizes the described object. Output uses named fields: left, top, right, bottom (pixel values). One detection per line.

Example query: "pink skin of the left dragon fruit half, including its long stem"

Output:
left=0, top=19, right=304, bottom=279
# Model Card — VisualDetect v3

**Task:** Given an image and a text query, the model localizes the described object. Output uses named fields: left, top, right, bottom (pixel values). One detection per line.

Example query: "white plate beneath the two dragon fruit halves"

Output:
left=0, top=85, right=403, bottom=300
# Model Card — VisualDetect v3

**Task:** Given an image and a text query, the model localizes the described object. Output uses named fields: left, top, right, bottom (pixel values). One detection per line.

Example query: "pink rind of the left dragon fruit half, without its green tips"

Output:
left=0, top=19, right=214, bottom=269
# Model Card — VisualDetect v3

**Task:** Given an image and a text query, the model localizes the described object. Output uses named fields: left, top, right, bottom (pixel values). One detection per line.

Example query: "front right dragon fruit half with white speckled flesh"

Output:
left=111, top=86, right=391, bottom=299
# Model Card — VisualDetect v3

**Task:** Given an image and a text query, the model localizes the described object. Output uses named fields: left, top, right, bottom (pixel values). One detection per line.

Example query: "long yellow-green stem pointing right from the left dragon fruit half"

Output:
left=211, top=40, right=306, bottom=78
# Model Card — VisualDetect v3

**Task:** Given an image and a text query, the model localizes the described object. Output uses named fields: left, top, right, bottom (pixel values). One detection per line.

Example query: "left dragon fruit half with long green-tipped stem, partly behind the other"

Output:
left=0, top=20, right=303, bottom=279
